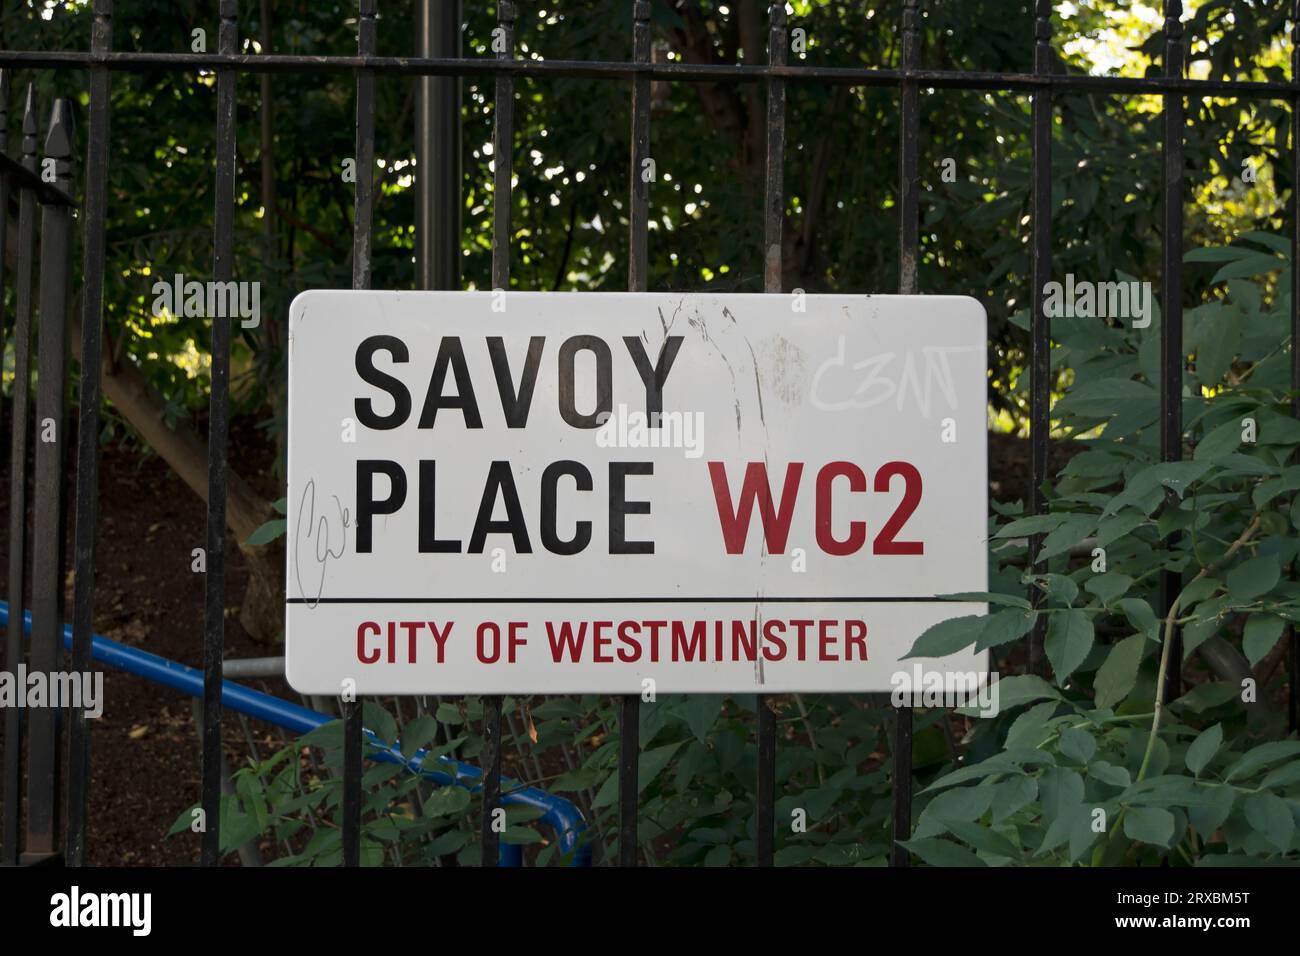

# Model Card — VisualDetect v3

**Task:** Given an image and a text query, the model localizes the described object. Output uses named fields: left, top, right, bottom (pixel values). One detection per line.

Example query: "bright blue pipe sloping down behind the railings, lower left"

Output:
left=0, top=601, right=592, bottom=866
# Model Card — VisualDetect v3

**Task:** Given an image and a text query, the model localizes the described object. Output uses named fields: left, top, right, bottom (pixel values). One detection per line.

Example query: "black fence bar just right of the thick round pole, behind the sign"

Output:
left=480, top=0, right=515, bottom=866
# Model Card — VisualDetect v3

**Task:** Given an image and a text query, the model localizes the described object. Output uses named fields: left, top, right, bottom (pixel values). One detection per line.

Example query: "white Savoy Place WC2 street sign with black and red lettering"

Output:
left=286, top=291, right=988, bottom=695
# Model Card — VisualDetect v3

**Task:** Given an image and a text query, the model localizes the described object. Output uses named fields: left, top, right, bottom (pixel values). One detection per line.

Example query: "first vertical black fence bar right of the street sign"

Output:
left=1026, top=0, right=1053, bottom=675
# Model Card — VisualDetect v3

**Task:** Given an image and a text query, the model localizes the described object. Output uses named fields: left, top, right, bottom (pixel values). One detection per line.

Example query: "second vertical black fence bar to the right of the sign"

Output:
left=1160, top=0, right=1184, bottom=704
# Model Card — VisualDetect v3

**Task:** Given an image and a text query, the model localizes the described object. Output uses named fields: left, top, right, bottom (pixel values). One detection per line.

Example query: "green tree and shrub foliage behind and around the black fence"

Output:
left=3, top=0, right=1300, bottom=865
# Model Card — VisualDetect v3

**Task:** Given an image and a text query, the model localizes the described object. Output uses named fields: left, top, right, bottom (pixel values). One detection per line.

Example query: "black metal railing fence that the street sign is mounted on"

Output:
left=0, top=0, right=1300, bottom=866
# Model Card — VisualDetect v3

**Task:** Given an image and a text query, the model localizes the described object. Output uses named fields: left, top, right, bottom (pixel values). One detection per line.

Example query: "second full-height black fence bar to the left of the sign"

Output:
left=68, top=0, right=113, bottom=866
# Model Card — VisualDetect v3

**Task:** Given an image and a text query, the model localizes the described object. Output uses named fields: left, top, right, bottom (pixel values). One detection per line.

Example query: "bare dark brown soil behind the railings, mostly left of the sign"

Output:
left=0, top=428, right=1069, bottom=865
